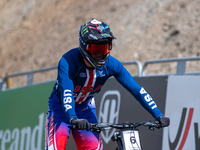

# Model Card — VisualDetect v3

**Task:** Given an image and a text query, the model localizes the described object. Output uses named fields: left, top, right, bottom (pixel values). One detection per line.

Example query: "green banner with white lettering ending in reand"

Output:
left=0, top=83, right=54, bottom=150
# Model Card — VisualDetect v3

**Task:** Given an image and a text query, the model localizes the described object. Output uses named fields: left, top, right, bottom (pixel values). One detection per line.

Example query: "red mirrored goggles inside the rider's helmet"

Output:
left=86, top=44, right=112, bottom=55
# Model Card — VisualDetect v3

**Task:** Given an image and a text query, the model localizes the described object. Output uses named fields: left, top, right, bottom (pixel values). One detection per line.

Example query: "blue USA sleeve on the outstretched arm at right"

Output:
left=109, top=57, right=163, bottom=119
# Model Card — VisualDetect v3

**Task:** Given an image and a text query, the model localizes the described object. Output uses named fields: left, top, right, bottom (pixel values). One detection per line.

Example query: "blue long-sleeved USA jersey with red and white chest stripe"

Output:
left=49, top=48, right=163, bottom=121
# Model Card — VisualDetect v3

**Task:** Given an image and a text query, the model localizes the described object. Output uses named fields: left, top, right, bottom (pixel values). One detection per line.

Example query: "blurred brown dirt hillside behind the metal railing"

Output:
left=0, top=0, right=200, bottom=82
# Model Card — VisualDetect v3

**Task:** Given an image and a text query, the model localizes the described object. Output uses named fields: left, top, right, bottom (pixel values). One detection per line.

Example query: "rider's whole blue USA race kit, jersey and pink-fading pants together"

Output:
left=45, top=48, right=163, bottom=150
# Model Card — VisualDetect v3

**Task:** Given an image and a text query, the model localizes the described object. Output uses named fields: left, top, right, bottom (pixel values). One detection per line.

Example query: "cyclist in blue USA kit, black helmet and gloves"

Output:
left=45, top=19, right=169, bottom=150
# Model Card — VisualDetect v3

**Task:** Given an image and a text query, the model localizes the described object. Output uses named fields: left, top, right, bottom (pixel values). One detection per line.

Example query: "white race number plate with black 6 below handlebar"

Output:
left=121, top=129, right=142, bottom=150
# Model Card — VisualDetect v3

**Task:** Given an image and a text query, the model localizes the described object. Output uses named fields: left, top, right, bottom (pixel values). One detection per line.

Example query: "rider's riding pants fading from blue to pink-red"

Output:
left=45, top=108, right=103, bottom=150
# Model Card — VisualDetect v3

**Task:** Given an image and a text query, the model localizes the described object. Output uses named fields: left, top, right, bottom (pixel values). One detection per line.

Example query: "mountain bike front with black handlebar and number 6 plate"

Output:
left=90, top=121, right=160, bottom=150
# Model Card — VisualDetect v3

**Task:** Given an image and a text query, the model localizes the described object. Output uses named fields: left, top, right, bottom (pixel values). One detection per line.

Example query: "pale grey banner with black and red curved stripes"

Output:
left=162, top=76, right=200, bottom=150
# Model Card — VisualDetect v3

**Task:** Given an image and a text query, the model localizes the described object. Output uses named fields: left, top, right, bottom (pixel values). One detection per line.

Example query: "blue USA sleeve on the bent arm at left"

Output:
left=58, top=58, right=77, bottom=121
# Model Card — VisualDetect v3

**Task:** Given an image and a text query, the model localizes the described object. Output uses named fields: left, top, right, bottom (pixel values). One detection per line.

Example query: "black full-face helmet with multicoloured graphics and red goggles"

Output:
left=79, top=19, right=116, bottom=70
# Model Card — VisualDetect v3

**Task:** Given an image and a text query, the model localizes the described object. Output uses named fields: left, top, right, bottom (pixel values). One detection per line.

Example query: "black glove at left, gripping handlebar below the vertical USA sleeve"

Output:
left=71, top=118, right=90, bottom=131
